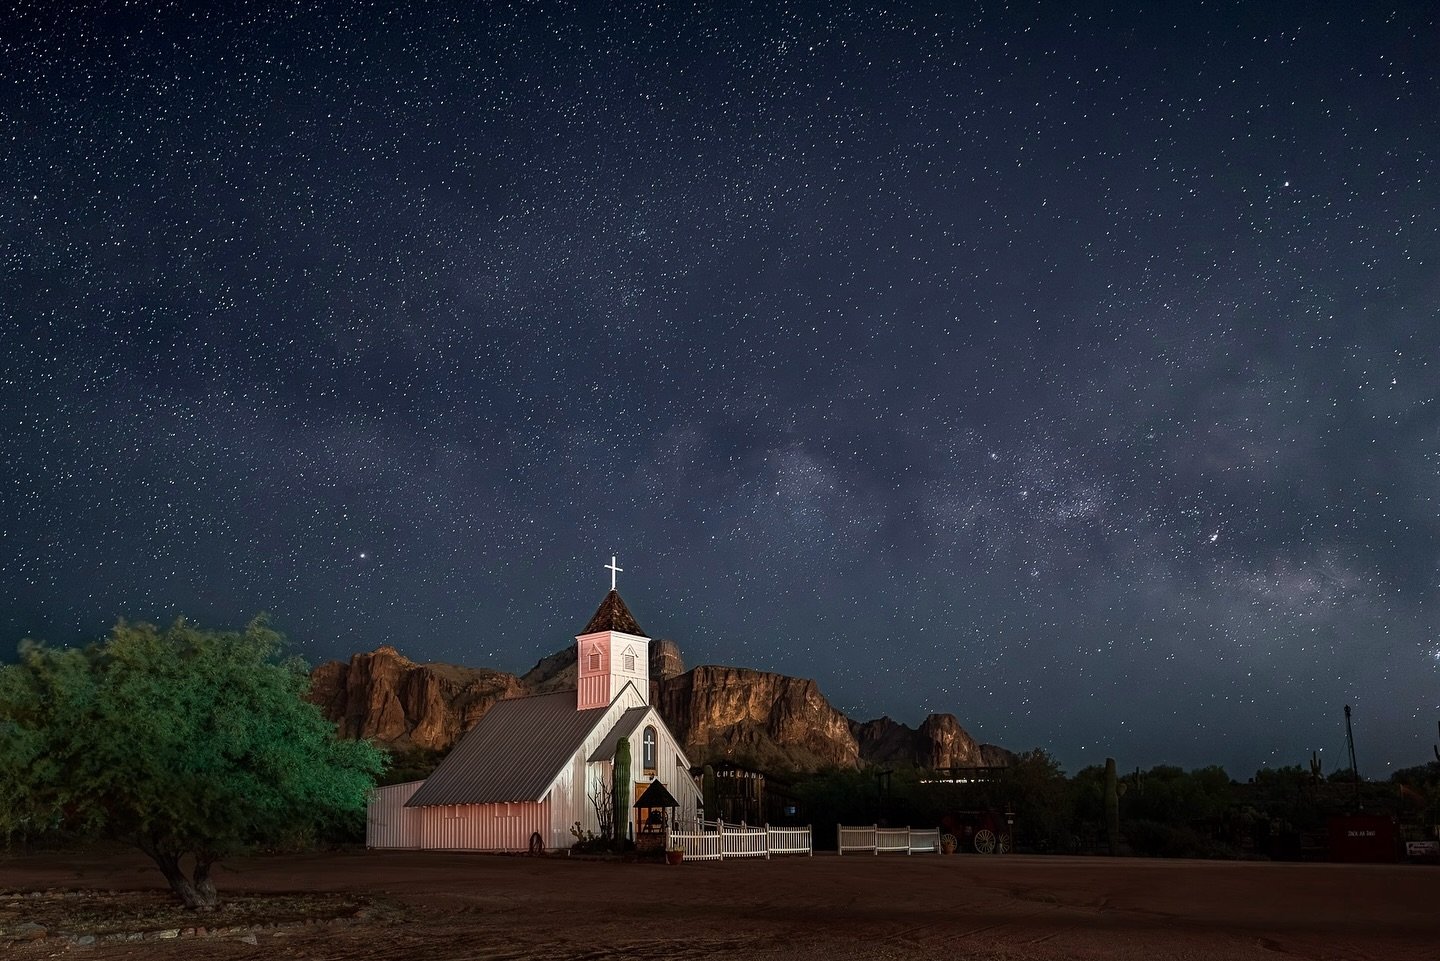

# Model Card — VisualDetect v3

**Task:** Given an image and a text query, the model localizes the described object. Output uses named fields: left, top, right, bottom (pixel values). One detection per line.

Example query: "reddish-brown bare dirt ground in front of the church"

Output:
left=0, top=852, right=1440, bottom=961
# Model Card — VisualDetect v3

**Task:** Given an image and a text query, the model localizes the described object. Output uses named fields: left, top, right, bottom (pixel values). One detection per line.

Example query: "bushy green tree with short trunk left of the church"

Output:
left=0, top=617, right=384, bottom=911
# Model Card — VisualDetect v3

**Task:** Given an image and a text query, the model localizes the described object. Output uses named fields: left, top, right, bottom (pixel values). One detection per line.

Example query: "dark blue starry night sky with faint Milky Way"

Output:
left=0, top=0, right=1440, bottom=778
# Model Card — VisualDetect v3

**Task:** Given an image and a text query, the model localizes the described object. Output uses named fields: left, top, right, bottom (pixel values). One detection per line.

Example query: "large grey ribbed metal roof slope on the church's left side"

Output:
left=405, top=690, right=607, bottom=807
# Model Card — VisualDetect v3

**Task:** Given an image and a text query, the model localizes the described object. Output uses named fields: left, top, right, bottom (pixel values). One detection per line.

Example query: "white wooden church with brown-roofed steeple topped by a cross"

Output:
left=366, top=567, right=700, bottom=852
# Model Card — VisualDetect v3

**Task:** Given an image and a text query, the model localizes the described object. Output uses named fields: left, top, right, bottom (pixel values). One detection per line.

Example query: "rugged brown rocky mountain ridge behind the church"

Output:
left=310, top=640, right=1011, bottom=772
